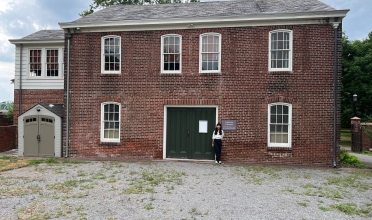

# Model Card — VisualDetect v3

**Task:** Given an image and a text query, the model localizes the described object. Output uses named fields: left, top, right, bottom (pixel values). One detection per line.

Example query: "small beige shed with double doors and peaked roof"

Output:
left=18, top=103, right=64, bottom=157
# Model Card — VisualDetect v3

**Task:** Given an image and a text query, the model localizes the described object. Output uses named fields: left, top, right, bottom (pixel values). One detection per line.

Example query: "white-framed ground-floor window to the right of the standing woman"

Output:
left=268, top=102, right=292, bottom=148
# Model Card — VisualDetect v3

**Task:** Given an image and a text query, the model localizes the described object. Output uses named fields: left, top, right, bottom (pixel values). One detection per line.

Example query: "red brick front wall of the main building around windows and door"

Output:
left=64, top=24, right=342, bottom=166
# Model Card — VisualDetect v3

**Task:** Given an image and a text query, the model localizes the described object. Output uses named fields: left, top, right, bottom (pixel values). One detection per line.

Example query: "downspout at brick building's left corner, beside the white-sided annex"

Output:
left=65, top=29, right=71, bottom=158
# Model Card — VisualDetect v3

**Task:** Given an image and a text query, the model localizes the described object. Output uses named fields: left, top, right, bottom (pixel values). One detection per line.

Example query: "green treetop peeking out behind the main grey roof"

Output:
left=79, top=0, right=199, bottom=17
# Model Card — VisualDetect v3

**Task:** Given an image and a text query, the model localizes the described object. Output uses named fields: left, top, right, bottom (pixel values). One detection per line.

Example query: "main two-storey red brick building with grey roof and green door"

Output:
left=11, top=0, right=348, bottom=166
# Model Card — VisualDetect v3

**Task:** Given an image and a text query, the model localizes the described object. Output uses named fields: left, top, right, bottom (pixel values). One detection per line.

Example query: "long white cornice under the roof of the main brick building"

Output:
left=59, top=10, right=349, bottom=32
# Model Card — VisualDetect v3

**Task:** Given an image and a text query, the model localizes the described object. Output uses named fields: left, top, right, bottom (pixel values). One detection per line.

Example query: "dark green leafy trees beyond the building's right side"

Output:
left=341, top=32, right=372, bottom=127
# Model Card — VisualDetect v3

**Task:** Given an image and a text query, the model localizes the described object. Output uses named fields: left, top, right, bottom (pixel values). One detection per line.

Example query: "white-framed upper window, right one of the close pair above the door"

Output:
left=199, top=33, right=221, bottom=73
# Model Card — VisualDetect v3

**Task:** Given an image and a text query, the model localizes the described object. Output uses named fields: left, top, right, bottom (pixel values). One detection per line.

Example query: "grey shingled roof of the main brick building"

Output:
left=71, top=0, right=336, bottom=24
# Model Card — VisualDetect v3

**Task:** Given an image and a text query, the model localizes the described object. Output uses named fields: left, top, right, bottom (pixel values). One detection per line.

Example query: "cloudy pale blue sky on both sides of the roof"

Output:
left=0, top=0, right=372, bottom=102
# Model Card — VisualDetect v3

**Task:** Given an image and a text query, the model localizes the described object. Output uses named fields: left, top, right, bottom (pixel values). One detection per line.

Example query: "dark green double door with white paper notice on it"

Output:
left=166, top=108, right=216, bottom=160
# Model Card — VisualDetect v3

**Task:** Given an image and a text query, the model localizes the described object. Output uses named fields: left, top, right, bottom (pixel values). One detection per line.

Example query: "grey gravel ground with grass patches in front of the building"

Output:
left=0, top=161, right=372, bottom=219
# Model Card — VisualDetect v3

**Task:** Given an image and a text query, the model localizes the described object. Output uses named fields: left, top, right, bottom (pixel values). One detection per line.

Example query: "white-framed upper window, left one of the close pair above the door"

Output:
left=161, top=34, right=182, bottom=73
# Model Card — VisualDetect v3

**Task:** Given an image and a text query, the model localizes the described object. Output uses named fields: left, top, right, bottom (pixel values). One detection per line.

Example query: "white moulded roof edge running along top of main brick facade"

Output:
left=58, top=9, right=350, bottom=29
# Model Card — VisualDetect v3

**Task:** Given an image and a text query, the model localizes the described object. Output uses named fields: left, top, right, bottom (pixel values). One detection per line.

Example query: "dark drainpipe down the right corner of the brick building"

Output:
left=333, top=18, right=339, bottom=168
